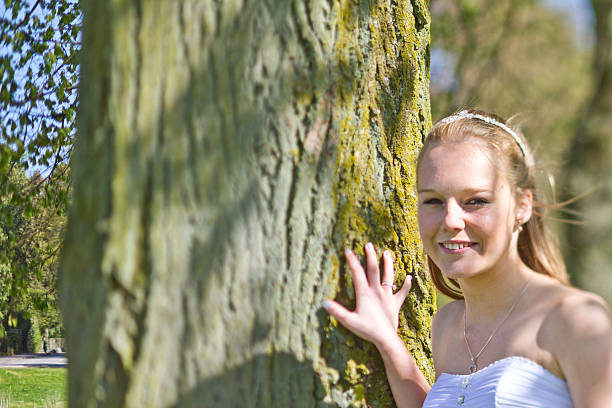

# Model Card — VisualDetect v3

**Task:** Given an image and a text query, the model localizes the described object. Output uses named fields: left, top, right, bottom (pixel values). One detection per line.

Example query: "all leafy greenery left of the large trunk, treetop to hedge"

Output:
left=0, top=0, right=81, bottom=337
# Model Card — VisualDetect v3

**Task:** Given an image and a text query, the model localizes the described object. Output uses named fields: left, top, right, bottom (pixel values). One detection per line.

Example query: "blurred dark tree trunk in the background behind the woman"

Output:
left=565, top=0, right=612, bottom=304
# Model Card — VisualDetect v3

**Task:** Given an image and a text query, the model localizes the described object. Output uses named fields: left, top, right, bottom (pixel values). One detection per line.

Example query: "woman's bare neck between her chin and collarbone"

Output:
left=459, top=253, right=535, bottom=326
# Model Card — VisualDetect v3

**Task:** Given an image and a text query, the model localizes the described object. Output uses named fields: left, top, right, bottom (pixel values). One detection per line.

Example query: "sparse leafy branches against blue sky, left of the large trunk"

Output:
left=0, top=0, right=81, bottom=185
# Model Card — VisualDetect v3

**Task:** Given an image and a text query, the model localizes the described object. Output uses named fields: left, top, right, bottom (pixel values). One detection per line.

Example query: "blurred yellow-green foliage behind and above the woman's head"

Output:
left=432, top=0, right=591, bottom=170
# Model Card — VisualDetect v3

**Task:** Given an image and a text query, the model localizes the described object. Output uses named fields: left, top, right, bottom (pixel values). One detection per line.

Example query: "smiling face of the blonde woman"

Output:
left=417, top=139, right=526, bottom=279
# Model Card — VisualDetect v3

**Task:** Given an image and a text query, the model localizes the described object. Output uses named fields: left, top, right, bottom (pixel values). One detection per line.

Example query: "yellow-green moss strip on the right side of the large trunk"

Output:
left=320, top=0, right=435, bottom=406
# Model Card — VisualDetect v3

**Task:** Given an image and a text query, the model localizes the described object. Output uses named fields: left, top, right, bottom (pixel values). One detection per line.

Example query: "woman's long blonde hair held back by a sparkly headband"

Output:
left=417, top=109, right=569, bottom=299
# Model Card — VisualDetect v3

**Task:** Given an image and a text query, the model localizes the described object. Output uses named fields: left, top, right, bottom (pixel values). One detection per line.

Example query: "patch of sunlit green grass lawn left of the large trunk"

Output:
left=0, top=368, right=67, bottom=408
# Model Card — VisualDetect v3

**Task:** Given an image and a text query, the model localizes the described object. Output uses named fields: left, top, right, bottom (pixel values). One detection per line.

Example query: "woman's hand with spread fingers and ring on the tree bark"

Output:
left=324, top=243, right=412, bottom=349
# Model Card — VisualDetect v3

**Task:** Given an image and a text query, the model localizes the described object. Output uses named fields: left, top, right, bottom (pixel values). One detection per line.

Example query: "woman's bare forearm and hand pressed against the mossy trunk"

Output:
left=326, top=244, right=430, bottom=408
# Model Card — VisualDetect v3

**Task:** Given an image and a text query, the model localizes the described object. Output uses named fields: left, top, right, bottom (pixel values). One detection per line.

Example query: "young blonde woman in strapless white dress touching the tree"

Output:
left=325, top=110, right=612, bottom=408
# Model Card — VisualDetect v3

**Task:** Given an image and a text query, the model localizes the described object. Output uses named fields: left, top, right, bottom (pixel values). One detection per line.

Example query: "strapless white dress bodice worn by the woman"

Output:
left=423, top=356, right=574, bottom=408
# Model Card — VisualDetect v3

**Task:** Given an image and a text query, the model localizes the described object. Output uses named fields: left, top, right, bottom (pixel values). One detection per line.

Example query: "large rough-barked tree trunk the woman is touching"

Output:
left=61, top=0, right=435, bottom=407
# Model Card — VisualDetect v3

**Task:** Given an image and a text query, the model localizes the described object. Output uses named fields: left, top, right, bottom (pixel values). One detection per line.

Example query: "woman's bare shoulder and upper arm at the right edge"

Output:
left=543, top=288, right=612, bottom=407
